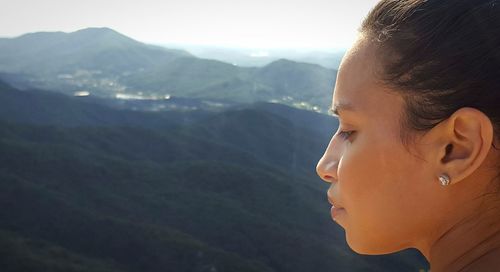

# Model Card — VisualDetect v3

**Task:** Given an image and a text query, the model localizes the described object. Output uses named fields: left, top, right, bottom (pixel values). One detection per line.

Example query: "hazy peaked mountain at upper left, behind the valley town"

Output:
left=0, top=28, right=189, bottom=76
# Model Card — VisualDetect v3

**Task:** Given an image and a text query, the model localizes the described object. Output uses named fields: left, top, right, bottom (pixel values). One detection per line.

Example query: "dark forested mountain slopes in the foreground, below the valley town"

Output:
left=0, top=79, right=427, bottom=272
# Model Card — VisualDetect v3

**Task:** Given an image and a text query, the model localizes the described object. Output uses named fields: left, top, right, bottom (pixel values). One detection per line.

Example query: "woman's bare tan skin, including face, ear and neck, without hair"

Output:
left=316, top=36, right=500, bottom=272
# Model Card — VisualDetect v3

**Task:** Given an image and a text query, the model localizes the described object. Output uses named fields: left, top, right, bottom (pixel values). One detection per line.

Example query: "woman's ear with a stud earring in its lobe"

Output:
left=425, top=107, right=494, bottom=184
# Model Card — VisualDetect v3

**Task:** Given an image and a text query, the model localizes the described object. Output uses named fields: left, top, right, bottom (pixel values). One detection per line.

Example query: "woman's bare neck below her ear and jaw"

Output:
left=422, top=199, right=500, bottom=272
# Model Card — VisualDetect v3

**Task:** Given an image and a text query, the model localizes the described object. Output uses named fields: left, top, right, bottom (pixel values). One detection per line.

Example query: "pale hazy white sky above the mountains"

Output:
left=0, top=0, right=377, bottom=49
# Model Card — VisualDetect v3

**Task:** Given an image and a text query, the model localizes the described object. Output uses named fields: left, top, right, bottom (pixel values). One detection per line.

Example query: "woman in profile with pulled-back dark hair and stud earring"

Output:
left=317, top=0, right=500, bottom=272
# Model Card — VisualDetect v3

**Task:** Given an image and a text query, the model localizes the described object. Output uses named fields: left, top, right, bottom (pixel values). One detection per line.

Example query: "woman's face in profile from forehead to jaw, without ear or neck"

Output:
left=317, top=38, right=440, bottom=254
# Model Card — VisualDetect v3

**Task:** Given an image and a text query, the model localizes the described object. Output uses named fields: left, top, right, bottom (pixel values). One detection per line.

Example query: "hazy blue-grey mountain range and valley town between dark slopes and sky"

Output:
left=0, top=28, right=336, bottom=115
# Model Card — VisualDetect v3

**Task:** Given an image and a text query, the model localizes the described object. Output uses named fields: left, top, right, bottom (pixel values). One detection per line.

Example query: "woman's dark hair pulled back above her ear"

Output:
left=360, top=0, right=500, bottom=146
